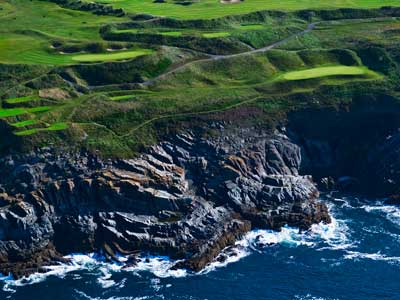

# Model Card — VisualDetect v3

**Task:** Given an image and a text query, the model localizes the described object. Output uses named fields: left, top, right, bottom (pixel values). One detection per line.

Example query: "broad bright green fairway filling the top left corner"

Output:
left=0, top=0, right=124, bottom=65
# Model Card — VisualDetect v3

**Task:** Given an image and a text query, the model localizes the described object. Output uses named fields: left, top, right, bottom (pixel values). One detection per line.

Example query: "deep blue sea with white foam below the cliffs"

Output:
left=0, top=197, right=400, bottom=300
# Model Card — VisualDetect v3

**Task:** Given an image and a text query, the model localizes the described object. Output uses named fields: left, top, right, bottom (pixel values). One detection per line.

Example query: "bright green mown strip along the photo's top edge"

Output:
left=85, top=0, right=400, bottom=19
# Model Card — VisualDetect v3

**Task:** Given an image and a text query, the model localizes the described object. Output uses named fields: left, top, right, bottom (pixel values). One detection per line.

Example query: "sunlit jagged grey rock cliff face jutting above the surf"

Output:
left=0, top=126, right=330, bottom=276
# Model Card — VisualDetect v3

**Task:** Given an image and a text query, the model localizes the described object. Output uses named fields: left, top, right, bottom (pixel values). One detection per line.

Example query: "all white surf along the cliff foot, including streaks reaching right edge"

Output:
left=0, top=195, right=400, bottom=300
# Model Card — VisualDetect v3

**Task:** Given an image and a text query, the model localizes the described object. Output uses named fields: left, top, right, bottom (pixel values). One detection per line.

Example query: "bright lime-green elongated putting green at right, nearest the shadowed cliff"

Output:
left=283, top=66, right=370, bottom=80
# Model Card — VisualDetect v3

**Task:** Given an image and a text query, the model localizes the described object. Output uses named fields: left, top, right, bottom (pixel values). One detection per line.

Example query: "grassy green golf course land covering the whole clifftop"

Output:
left=0, top=0, right=400, bottom=156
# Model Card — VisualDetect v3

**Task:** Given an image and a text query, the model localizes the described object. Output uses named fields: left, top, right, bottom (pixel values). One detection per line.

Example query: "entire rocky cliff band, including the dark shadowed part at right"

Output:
left=0, top=98, right=400, bottom=278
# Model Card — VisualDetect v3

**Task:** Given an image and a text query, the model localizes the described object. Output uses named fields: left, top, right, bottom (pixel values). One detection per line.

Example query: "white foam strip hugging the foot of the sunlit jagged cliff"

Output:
left=3, top=199, right=352, bottom=290
